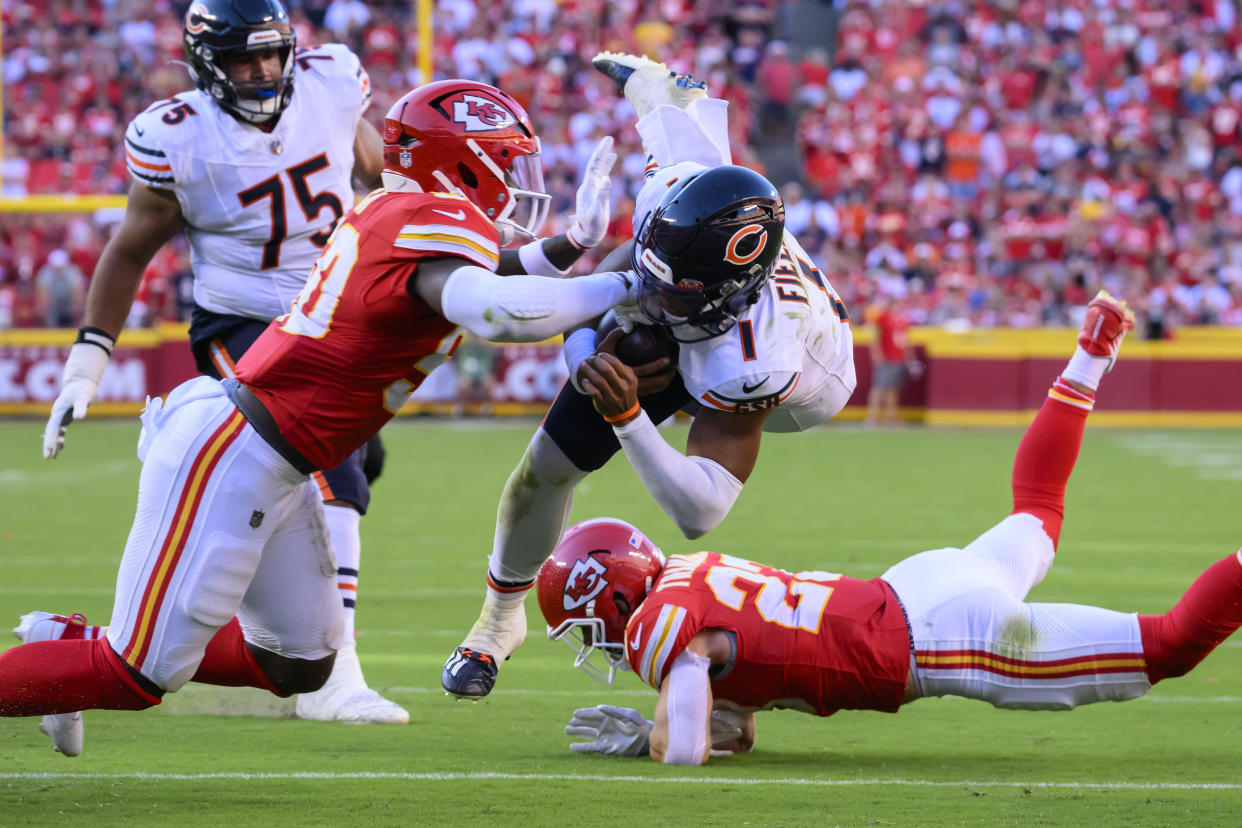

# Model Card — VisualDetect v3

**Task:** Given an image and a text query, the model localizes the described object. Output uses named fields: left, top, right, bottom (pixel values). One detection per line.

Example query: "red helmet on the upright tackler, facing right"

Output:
left=384, top=81, right=551, bottom=245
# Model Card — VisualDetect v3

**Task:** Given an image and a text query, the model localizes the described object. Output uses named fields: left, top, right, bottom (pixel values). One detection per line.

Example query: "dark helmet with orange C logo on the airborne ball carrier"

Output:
left=632, top=166, right=785, bottom=341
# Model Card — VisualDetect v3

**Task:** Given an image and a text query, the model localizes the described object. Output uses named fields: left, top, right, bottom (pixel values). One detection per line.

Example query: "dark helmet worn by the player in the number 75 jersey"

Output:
left=181, top=0, right=297, bottom=123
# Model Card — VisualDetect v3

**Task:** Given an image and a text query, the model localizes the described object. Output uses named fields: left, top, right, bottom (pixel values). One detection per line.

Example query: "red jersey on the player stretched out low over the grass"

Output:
left=626, top=552, right=910, bottom=716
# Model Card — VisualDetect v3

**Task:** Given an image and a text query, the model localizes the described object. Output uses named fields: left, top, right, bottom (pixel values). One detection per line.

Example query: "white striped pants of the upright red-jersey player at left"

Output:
left=108, top=377, right=343, bottom=691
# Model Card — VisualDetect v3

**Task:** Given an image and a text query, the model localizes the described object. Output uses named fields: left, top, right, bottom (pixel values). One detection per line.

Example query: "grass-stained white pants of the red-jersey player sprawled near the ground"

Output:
left=883, top=514, right=1151, bottom=710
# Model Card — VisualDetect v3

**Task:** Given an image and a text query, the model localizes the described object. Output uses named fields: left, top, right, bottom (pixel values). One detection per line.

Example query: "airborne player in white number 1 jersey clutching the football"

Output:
left=441, top=53, right=856, bottom=699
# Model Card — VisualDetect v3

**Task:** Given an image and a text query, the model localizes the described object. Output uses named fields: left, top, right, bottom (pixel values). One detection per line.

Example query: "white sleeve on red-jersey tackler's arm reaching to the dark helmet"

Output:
left=441, top=264, right=632, bottom=343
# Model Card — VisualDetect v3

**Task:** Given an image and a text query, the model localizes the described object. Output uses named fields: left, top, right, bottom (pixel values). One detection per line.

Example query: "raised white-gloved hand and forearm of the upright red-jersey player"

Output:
left=497, top=135, right=613, bottom=276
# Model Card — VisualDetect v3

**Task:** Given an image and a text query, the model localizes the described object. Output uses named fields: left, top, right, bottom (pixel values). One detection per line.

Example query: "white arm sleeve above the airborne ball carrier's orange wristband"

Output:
left=614, top=411, right=741, bottom=538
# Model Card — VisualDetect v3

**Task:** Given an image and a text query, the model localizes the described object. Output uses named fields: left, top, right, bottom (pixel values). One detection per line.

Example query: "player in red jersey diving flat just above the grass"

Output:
left=538, top=293, right=1242, bottom=765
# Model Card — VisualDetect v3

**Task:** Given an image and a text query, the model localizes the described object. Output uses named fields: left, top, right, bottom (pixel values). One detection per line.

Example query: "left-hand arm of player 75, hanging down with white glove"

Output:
left=43, top=182, right=184, bottom=458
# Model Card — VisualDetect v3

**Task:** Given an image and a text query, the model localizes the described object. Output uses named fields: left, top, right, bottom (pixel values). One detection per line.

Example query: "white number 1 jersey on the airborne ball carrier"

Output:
left=678, top=231, right=857, bottom=432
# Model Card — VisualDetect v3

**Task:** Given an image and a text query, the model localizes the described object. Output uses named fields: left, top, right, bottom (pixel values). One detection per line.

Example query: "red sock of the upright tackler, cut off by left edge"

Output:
left=0, top=638, right=160, bottom=716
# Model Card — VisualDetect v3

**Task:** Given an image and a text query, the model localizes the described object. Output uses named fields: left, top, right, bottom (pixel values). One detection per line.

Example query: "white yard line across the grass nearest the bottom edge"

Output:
left=0, top=772, right=1242, bottom=791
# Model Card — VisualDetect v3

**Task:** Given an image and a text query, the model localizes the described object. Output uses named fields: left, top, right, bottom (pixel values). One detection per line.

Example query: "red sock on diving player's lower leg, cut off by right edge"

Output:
left=1139, top=551, right=1242, bottom=684
